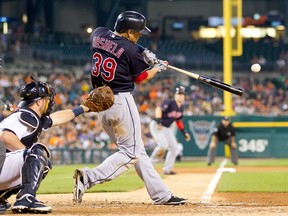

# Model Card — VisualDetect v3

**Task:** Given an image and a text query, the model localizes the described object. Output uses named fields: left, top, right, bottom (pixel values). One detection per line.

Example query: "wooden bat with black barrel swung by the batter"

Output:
left=168, top=65, right=244, bottom=96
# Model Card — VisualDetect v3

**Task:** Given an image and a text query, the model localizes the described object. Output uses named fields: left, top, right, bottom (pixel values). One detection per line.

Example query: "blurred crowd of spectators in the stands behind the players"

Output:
left=0, top=70, right=288, bottom=154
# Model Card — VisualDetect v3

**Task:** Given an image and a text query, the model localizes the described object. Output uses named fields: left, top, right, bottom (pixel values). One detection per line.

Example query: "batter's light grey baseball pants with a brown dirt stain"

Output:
left=77, top=93, right=172, bottom=204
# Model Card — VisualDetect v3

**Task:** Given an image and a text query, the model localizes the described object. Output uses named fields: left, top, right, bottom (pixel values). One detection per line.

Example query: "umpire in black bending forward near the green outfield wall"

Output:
left=208, top=116, right=238, bottom=166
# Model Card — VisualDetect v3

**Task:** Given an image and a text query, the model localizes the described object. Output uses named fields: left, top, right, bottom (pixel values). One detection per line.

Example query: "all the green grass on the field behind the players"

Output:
left=38, top=158, right=288, bottom=194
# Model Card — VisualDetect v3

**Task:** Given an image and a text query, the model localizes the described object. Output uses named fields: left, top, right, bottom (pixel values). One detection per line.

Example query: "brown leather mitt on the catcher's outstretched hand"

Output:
left=81, top=85, right=114, bottom=112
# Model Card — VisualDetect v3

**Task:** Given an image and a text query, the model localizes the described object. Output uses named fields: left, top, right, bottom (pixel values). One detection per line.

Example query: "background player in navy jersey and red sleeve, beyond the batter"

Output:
left=150, top=86, right=190, bottom=175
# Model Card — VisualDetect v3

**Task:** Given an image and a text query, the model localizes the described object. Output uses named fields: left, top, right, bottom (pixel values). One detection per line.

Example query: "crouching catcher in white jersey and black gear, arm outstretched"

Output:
left=0, top=81, right=88, bottom=213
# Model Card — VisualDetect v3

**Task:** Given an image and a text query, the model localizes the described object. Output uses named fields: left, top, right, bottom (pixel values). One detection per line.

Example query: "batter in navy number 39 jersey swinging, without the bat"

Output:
left=73, top=11, right=186, bottom=205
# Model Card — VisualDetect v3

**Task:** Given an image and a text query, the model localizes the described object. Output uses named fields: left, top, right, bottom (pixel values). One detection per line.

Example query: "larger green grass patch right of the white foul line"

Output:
left=217, top=172, right=288, bottom=192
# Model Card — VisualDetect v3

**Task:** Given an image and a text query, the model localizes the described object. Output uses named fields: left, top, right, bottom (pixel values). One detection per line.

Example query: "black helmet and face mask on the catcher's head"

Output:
left=18, top=80, right=55, bottom=114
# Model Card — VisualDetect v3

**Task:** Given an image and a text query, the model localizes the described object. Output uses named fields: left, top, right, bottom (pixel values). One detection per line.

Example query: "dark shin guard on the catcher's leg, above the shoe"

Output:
left=16, top=143, right=50, bottom=199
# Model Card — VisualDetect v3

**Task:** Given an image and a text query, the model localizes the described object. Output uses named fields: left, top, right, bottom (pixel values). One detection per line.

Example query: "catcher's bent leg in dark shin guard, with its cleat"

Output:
left=12, top=143, right=52, bottom=214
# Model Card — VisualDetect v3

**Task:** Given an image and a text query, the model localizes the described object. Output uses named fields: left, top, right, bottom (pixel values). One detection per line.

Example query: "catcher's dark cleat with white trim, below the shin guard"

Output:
left=11, top=194, right=52, bottom=214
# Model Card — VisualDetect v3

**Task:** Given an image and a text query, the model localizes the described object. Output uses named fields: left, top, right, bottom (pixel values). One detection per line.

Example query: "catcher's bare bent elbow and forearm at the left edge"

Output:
left=0, top=130, right=25, bottom=151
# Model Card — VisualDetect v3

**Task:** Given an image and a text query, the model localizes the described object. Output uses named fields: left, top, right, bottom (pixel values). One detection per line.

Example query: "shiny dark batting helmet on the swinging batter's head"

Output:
left=114, top=11, right=151, bottom=35
